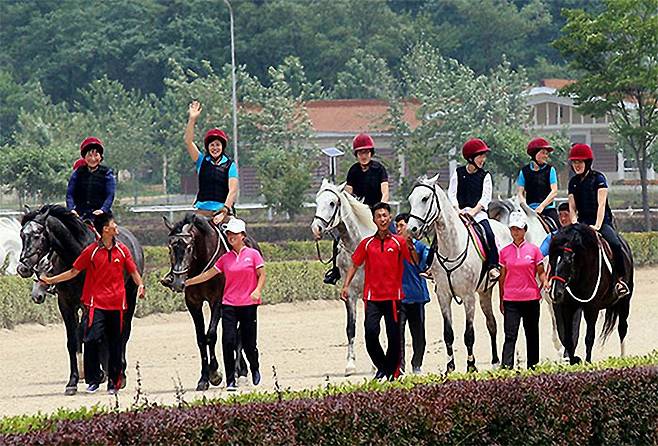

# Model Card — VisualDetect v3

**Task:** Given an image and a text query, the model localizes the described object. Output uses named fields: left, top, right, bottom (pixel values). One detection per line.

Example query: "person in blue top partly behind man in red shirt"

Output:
left=395, top=214, right=430, bottom=374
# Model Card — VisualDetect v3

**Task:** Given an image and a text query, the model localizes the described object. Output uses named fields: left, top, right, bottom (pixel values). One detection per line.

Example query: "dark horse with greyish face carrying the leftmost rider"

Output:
left=17, top=205, right=144, bottom=395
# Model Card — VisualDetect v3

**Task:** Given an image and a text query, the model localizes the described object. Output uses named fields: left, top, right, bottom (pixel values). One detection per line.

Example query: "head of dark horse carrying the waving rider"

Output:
left=163, top=215, right=197, bottom=293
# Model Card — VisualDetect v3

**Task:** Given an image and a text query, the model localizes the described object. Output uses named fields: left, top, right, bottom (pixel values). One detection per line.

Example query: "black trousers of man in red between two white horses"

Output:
left=364, top=300, right=400, bottom=378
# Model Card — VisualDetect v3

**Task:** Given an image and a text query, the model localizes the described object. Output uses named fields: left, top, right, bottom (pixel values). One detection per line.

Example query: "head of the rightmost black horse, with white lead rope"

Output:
left=549, top=224, right=596, bottom=304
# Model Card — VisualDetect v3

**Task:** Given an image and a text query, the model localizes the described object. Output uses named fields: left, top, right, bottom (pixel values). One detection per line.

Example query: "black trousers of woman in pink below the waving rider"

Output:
left=222, top=305, right=259, bottom=384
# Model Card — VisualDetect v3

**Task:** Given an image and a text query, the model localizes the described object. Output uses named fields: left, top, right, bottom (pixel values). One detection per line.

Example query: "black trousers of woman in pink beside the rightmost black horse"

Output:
left=503, top=300, right=539, bottom=368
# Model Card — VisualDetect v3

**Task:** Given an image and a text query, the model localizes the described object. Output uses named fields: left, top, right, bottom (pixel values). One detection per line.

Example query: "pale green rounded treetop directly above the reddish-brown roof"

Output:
left=331, top=48, right=395, bottom=99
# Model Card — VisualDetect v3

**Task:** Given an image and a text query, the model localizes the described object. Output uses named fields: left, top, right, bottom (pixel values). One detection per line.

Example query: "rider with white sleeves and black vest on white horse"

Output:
left=448, top=138, right=500, bottom=280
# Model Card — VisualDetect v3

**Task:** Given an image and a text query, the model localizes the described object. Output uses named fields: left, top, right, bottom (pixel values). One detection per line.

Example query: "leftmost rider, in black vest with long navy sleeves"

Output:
left=66, top=136, right=116, bottom=219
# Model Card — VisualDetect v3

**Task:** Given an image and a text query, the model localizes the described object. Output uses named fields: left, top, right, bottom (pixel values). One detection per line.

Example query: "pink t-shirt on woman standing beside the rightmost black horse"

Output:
left=500, top=241, right=544, bottom=301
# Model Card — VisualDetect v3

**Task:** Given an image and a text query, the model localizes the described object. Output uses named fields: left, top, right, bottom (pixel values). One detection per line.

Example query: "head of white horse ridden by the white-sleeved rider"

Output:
left=407, top=174, right=441, bottom=238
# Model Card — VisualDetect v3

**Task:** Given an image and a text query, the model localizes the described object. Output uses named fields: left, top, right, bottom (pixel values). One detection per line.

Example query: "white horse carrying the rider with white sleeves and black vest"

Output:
left=407, top=174, right=512, bottom=372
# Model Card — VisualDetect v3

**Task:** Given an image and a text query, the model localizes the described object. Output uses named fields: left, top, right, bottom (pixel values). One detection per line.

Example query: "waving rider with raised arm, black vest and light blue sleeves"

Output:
left=185, top=101, right=239, bottom=224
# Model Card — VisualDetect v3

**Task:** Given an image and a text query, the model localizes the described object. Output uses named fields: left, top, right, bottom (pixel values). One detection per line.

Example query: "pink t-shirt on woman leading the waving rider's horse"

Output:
left=210, top=246, right=265, bottom=307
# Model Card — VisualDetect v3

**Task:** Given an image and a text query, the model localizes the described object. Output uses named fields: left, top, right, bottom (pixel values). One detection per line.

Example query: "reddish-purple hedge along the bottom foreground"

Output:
left=0, top=362, right=658, bottom=445
